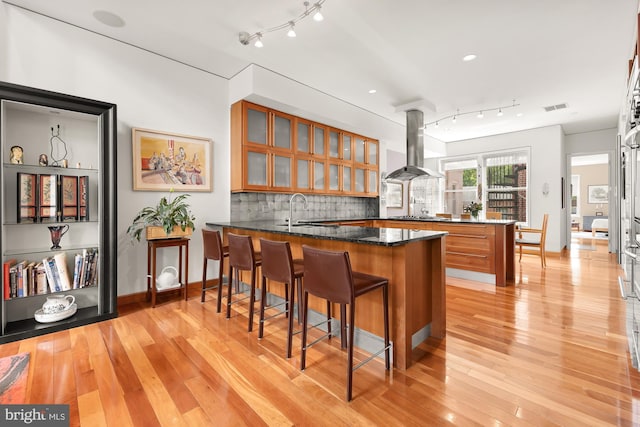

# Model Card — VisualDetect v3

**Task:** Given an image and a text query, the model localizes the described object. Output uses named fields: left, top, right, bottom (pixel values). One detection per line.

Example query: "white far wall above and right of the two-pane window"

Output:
left=442, top=126, right=566, bottom=252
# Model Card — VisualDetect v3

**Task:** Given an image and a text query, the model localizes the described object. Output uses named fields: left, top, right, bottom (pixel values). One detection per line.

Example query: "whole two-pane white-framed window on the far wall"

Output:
left=440, top=149, right=529, bottom=222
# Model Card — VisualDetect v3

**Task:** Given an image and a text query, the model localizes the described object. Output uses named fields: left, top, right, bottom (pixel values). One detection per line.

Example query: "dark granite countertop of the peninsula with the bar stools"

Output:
left=206, top=218, right=447, bottom=246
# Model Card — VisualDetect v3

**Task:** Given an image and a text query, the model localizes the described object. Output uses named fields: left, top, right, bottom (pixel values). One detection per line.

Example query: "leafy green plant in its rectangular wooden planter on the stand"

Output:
left=127, top=190, right=195, bottom=241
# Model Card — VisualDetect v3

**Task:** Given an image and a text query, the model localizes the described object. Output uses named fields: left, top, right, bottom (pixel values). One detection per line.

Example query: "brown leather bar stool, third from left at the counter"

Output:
left=258, top=239, right=304, bottom=358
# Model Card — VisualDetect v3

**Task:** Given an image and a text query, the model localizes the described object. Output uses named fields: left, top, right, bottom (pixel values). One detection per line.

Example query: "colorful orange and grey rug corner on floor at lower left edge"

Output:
left=0, top=353, right=31, bottom=405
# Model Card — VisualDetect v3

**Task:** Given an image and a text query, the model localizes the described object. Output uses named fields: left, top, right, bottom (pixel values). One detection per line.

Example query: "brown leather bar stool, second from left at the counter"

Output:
left=227, top=233, right=262, bottom=332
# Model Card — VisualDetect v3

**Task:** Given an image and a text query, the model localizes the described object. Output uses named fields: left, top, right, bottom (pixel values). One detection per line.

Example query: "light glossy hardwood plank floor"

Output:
left=0, top=239, right=640, bottom=426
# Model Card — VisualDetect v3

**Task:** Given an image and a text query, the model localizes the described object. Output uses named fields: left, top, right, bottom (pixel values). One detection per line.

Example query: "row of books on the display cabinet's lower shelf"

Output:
left=3, top=248, right=98, bottom=300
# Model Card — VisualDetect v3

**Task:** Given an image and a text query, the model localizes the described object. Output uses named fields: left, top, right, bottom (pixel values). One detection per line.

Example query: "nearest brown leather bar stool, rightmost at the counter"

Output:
left=300, top=245, right=391, bottom=401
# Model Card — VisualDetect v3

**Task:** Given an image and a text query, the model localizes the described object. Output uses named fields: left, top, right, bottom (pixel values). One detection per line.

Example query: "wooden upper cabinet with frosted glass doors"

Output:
left=231, top=101, right=379, bottom=197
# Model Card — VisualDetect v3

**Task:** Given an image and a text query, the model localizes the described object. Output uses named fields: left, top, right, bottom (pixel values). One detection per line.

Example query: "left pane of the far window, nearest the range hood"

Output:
left=441, top=158, right=479, bottom=215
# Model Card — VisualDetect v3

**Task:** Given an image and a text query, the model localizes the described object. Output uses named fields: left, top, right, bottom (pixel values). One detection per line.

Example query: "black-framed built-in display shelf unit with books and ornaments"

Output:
left=0, top=82, right=117, bottom=343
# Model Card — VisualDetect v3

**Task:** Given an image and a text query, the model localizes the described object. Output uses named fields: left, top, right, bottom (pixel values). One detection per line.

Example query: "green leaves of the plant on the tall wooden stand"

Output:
left=127, top=190, right=196, bottom=241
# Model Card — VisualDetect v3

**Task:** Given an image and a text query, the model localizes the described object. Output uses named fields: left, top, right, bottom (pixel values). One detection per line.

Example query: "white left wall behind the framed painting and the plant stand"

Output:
left=0, top=3, right=230, bottom=295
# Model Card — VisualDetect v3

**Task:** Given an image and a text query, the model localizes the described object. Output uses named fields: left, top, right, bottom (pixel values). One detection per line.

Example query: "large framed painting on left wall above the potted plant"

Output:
left=132, top=128, right=213, bottom=192
